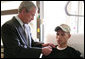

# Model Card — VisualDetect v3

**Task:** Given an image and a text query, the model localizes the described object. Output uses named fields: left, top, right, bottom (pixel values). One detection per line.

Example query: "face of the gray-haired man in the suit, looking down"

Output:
left=23, top=7, right=36, bottom=24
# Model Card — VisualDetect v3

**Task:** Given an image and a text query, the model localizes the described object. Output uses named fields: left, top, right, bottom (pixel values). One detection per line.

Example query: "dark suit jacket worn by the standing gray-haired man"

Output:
left=1, top=17, right=42, bottom=58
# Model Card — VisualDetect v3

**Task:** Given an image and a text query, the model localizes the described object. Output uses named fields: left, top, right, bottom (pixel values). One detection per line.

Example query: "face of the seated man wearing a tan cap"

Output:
left=56, top=30, right=70, bottom=45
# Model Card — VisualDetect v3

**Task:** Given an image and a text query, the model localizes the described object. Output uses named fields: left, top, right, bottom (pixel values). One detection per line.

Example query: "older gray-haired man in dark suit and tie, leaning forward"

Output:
left=1, top=1, right=54, bottom=58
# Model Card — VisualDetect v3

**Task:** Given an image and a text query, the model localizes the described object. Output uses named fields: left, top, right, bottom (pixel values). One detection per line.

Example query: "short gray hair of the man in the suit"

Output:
left=18, top=1, right=36, bottom=13
